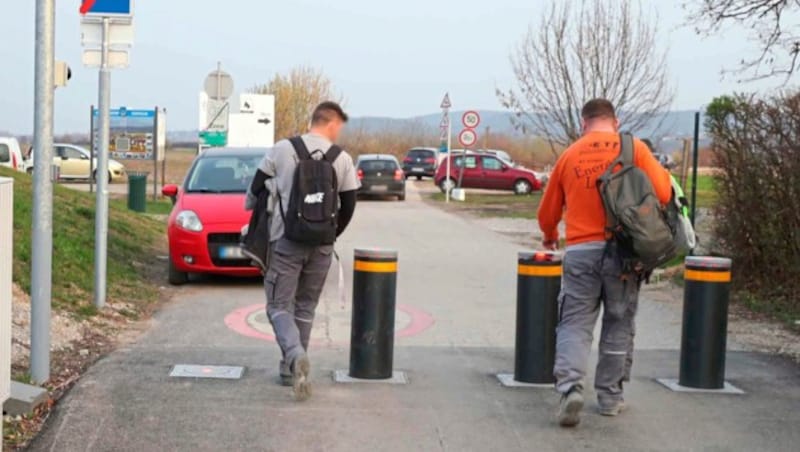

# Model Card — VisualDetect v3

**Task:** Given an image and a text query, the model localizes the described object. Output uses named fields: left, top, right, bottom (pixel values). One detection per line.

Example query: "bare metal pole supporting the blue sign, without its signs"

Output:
left=94, top=17, right=111, bottom=309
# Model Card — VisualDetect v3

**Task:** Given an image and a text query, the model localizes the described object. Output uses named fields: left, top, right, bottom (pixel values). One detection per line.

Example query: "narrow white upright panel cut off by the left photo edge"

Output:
left=0, top=177, right=14, bottom=414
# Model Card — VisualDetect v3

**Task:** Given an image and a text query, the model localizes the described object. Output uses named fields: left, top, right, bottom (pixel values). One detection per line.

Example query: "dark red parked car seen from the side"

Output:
left=434, top=153, right=542, bottom=195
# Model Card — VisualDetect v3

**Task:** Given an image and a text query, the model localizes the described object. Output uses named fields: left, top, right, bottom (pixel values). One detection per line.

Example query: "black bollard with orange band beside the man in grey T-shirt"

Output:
left=349, top=249, right=397, bottom=380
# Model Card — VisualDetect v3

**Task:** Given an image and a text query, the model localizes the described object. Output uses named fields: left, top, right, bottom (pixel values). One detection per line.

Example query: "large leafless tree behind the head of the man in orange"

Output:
left=497, top=0, right=674, bottom=154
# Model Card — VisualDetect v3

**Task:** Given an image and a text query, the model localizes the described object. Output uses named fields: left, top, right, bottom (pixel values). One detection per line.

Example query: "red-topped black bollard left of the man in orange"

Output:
left=514, top=251, right=561, bottom=384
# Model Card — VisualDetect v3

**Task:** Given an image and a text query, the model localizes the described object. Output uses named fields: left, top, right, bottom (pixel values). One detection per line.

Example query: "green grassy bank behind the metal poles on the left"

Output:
left=0, top=168, right=168, bottom=317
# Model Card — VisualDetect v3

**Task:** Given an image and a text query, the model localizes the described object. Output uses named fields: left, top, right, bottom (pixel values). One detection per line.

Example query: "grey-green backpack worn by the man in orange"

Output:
left=597, top=133, right=677, bottom=273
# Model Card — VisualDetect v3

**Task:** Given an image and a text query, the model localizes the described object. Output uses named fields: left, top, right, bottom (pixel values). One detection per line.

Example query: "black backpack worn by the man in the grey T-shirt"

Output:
left=278, top=137, right=342, bottom=246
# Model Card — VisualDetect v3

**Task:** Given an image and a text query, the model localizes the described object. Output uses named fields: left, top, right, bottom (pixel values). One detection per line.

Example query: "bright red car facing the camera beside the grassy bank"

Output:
left=162, top=148, right=266, bottom=285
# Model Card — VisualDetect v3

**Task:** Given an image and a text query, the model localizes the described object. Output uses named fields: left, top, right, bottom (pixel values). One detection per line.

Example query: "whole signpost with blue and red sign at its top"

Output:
left=80, top=0, right=133, bottom=309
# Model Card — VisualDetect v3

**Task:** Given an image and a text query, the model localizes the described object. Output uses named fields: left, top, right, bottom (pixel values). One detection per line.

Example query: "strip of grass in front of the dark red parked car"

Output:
left=430, top=191, right=542, bottom=220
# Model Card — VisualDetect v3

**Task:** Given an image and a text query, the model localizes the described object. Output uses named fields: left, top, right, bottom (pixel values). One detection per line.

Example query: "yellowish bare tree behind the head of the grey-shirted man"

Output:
left=251, top=66, right=341, bottom=139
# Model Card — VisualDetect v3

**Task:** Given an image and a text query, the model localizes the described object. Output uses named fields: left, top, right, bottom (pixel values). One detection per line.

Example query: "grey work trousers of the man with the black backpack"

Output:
left=264, top=238, right=333, bottom=365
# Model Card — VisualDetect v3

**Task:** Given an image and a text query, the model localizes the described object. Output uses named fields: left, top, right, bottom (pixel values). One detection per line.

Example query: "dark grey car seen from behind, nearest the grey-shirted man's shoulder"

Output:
left=356, top=154, right=406, bottom=201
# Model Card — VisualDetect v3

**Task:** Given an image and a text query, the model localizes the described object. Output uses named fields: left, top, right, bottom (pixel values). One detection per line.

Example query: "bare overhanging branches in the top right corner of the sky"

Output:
left=684, top=0, right=800, bottom=81
